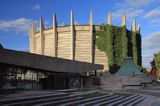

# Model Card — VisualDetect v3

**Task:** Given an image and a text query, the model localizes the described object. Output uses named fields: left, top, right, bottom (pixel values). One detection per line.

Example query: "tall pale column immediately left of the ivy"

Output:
left=90, top=11, right=93, bottom=63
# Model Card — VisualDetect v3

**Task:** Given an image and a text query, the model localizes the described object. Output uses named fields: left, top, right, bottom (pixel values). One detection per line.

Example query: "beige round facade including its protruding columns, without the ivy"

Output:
left=30, top=11, right=141, bottom=72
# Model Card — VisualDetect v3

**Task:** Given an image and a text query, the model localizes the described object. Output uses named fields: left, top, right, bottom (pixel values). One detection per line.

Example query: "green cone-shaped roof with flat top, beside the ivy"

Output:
left=116, top=57, right=142, bottom=75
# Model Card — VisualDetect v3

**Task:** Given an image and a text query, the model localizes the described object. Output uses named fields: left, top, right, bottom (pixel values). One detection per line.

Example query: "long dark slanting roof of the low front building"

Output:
left=0, top=49, right=103, bottom=73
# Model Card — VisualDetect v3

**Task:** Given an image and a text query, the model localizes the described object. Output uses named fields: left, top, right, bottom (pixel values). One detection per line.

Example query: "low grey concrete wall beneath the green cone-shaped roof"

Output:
left=101, top=73, right=153, bottom=90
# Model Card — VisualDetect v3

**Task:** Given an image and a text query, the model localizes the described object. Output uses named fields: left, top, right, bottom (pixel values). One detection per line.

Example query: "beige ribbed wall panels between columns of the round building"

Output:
left=30, top=25, right=108, bottom=70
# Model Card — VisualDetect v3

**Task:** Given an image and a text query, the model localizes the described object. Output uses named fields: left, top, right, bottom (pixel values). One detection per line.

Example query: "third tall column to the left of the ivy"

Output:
left=53, top=14, right=58, bottom=57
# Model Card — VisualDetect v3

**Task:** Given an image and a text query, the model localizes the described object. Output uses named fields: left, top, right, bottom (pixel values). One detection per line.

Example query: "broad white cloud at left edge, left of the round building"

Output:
left=0, top=18, right=32, bottom=32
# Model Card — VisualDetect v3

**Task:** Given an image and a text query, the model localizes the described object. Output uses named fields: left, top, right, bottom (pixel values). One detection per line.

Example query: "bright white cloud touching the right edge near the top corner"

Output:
left=144, top=7, right=160, bottom=18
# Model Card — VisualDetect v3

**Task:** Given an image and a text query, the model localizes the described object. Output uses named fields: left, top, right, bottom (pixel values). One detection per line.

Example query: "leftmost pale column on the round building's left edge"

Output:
left=29, top=21, right=36, bottom=53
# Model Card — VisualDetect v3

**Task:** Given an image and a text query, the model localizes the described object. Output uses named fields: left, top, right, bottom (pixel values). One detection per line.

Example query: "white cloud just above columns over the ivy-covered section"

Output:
left=113, top=8, right=143, bottom=21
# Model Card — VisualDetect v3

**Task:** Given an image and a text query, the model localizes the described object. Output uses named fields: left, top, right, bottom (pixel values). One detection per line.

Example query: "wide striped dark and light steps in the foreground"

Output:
left=0, top=93, right=146, bottom=106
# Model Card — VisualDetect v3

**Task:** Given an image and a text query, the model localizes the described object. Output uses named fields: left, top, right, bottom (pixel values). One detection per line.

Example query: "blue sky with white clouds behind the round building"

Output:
left=0, top=0, right=160, bottom=67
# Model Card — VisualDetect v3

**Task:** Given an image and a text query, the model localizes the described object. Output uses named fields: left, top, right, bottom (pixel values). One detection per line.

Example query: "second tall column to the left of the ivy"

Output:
left=70, top=11, right=75, bottom=60
